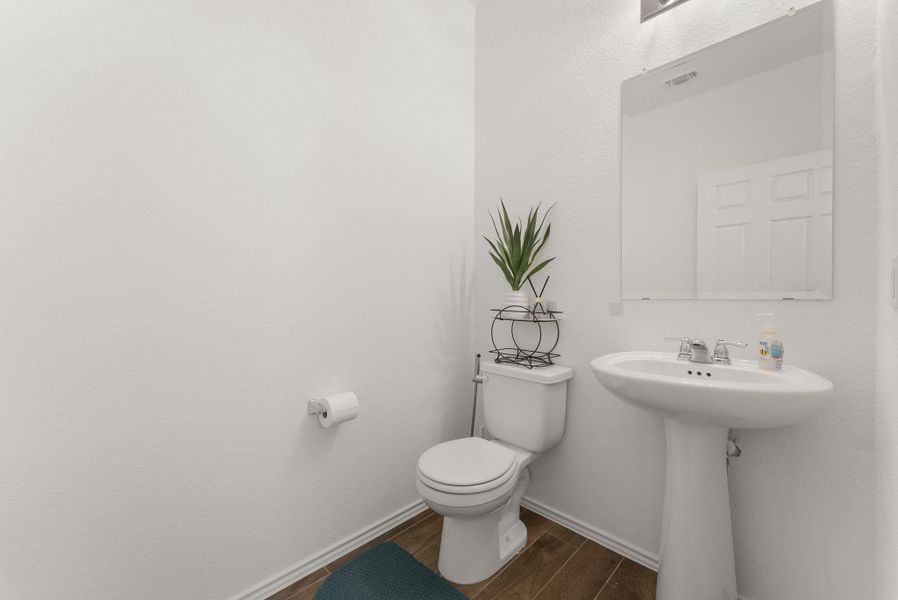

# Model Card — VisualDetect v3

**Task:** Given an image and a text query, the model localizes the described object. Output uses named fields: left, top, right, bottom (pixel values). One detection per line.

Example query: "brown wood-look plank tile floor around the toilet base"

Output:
left=267, top=510, right=655, bottom=600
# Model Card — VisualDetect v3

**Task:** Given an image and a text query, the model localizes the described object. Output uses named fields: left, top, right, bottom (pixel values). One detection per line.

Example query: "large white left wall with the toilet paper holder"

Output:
left=0, top=0, right=474, bottom=600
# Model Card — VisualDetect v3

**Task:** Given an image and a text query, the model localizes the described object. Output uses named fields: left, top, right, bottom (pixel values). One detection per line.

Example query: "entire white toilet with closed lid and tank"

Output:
left=416, top=363, right=573, bottom=584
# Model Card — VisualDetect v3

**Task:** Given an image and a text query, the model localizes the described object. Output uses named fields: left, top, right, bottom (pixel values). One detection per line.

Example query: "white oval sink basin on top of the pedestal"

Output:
left=590, top=352, right=833, bottom=429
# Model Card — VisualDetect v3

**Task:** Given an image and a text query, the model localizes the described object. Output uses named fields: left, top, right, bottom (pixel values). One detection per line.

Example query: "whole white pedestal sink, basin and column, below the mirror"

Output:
left=590, top=352, right=833, bottom=600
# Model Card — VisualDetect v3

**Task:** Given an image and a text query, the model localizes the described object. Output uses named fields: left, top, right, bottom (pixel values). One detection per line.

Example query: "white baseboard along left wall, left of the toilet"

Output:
left=229, top=500, right=427, bottom=600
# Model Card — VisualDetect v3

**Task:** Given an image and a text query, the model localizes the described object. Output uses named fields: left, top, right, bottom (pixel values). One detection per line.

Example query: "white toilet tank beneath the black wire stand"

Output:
left=481, top=363, right=574, bottom=452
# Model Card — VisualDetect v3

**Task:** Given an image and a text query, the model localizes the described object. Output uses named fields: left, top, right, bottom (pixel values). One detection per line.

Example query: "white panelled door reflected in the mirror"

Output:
left=696, top=150, right=832, bottom=299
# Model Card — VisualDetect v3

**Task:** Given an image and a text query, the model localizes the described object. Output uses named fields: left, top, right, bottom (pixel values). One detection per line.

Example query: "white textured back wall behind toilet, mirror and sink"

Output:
left=474, top=0, right=877, bottom=600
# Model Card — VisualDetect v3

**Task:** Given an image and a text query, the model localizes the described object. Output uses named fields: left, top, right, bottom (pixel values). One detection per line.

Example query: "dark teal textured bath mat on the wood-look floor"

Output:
left=315, top=542, right=467, bottom=600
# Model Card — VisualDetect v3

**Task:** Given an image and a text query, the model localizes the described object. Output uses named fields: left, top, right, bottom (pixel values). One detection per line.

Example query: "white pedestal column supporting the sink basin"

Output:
left=656, top=417, right=736, bottom=600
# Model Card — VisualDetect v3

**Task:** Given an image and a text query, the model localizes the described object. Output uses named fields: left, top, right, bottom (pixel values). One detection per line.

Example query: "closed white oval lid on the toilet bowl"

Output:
left=418, top=438, right=515, bottom=486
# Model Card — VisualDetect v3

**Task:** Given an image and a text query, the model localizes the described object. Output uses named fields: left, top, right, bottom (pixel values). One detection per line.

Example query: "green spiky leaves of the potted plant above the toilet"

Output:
left=483, top=198, right=555, bottom=291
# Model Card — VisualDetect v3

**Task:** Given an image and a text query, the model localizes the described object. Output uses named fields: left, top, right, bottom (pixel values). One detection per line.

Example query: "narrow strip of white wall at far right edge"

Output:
left=875, top=1, right=898, bottom=600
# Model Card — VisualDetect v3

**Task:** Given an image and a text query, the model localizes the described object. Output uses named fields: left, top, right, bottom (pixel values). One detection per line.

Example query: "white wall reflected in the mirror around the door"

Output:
left=621, top=53, right=833, bottom=298
